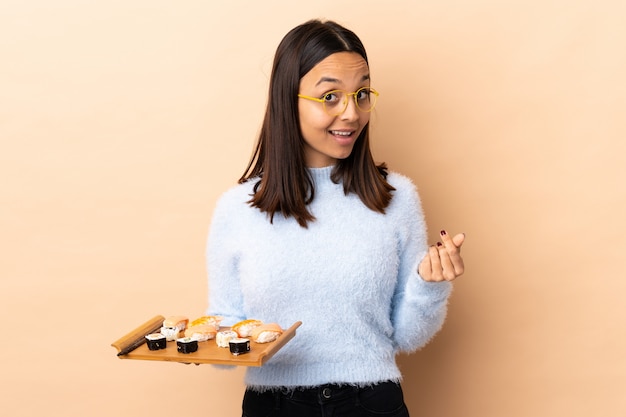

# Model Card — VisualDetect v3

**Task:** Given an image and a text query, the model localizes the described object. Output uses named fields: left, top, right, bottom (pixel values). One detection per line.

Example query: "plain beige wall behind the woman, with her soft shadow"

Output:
left=0, top=0, right=626, bottom=417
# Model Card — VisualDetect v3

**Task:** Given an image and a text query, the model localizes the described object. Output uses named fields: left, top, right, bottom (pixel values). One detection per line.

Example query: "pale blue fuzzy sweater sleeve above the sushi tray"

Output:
left=206, top=190, right=245, bottom=326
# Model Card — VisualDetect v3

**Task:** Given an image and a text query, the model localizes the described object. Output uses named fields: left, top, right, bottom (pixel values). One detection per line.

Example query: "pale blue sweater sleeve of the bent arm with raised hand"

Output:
left=391, top=174, right=452, bottom=352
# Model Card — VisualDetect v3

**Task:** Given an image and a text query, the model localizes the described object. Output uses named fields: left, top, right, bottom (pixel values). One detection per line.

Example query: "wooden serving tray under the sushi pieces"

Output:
left=111, top=316, right=302, bottom=366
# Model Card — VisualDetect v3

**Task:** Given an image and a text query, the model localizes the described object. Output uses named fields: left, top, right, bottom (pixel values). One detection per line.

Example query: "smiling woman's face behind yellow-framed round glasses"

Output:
left=298, top=52, right=370, bottom=168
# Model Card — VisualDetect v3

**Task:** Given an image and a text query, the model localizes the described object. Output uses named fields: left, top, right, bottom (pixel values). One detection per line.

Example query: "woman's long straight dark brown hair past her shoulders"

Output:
left=239, top=20, right=394, bottom=227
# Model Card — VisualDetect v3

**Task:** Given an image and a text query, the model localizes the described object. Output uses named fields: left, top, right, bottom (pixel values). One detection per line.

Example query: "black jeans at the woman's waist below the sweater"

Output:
left=242, top=381, right=409, bottom=417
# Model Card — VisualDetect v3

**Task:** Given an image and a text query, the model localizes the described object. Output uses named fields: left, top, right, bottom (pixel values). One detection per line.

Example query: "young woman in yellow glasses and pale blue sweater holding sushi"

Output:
left=207, top=21, right=464, bottom=417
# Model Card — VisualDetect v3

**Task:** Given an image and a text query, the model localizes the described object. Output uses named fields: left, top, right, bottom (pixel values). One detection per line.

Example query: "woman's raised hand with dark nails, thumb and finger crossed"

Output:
left=417, top=230, right=465, bottom=282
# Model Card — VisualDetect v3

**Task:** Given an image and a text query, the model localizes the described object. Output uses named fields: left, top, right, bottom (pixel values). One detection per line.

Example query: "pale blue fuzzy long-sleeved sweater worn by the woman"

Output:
left=207, top=167, right=451, bottom=390
